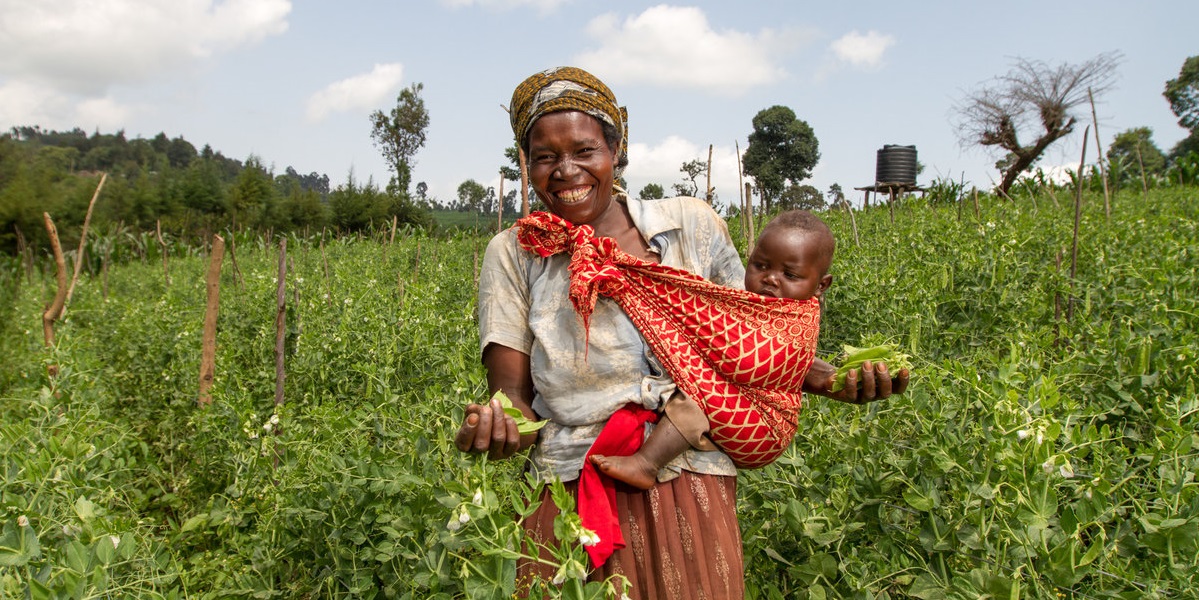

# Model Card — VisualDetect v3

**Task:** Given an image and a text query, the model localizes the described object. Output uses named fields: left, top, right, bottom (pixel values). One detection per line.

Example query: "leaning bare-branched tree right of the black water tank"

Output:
left=956, top=52, right=1121, bottom=193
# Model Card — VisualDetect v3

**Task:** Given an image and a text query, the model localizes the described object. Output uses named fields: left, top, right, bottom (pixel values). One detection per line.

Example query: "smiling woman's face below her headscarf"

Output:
left=529, top=110, right=616, bottom=224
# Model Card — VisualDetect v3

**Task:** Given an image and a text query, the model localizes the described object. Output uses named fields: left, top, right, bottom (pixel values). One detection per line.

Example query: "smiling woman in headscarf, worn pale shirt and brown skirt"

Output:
left=456, top=67, right=891, bottom=599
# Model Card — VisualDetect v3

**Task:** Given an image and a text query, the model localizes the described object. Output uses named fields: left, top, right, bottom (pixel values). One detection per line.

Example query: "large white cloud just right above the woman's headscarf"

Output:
left=574, top=5, right=808, bottom=95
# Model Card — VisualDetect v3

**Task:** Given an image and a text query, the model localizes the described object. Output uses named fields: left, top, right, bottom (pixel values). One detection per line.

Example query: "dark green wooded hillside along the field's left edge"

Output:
left=0, top=126, right=432, bottom=253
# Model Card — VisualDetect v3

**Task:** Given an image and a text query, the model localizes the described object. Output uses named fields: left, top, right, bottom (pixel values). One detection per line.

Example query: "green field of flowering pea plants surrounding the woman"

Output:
left=0, top=186, right=1199, bottom=599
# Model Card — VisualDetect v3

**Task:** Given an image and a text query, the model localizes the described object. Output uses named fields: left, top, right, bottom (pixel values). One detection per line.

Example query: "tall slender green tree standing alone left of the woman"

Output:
left=370, top=83, right=429, bottom=194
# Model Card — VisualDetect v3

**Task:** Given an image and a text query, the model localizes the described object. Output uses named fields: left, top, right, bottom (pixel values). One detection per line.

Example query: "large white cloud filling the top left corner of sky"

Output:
left=0, top=0, right=291, bottom=96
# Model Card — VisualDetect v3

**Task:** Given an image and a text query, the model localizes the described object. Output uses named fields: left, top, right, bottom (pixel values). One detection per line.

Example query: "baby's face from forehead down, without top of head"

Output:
left=746, top=228, right=832, bottom=300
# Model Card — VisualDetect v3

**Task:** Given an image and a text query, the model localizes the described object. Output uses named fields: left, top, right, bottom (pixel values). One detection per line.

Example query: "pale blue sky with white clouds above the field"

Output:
left=0, top=0, right=1199, bottom=202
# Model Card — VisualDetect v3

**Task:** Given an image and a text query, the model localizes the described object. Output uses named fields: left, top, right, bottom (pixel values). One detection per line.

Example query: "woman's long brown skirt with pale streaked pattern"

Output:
left=517, top=470, right=745, bottom=600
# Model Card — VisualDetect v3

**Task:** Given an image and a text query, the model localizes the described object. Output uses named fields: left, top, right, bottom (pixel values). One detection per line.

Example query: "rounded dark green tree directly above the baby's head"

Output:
left=742, top=106, right=820, bottom=212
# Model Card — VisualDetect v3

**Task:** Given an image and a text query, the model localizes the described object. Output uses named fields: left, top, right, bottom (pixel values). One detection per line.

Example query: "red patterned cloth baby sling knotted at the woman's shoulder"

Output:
left=517, top=212, right=820, bottom=468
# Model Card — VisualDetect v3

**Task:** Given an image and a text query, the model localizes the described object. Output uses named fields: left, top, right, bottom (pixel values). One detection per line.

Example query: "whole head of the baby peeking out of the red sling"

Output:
left=746, top=210, right=837, bottom=300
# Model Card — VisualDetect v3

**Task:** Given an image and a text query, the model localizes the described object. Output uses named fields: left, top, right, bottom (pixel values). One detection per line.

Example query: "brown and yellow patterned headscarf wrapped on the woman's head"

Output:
left=508, top=67, right=628, bottom=179
